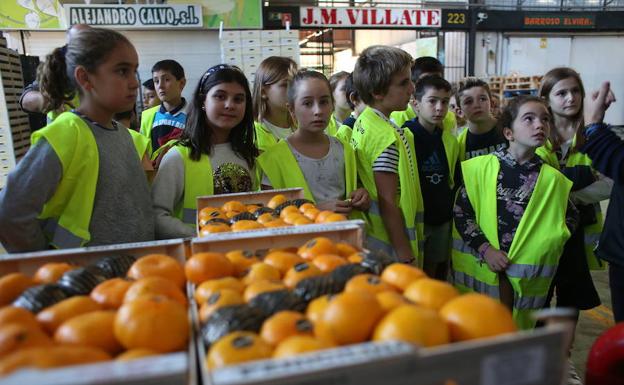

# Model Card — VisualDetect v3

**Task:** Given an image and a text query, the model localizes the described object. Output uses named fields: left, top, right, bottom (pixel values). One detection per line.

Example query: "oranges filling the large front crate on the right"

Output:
left=186, top=237, right=516, bottom=369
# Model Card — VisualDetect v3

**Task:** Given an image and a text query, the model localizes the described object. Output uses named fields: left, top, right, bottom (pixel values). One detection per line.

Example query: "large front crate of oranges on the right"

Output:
left=186, top=221, right=565, bottom=385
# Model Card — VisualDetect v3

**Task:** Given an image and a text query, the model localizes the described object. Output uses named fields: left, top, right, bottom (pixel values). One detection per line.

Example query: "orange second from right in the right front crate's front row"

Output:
left=373, top=305, right=450, bottom=347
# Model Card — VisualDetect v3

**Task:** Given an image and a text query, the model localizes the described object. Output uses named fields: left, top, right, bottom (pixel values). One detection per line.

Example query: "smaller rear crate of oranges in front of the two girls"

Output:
left=196, top=188, right=348, bottom=237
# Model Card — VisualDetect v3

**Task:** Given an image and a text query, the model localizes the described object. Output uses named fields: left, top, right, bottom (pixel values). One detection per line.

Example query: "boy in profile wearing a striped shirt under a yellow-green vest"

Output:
left=351, top=45, right=423, bottom=264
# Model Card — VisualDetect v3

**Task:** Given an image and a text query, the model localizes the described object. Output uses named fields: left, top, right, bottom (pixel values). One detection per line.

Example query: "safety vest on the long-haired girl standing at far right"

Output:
left=536, top=135, right=606, bottom=270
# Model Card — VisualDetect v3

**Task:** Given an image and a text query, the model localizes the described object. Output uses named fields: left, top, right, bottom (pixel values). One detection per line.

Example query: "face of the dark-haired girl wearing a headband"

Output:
left=203, top=82, right=246, bottom=133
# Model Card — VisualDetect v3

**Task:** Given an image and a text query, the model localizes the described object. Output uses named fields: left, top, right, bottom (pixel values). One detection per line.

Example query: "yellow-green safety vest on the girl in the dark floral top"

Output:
left=452, top=155, right=572, bottom=329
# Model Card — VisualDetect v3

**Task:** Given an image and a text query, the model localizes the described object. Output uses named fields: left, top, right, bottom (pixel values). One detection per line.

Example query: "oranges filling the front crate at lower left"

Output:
left=0, top=254, right=190, bottom=376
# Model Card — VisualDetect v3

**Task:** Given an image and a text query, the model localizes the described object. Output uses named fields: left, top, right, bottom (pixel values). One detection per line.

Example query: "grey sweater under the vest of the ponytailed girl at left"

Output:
left=0, top=122, right=154, bottom=252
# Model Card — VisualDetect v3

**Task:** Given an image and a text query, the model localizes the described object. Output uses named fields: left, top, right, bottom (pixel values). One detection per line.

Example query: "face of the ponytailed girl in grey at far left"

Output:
left=84, top=43, right=139, bottom=113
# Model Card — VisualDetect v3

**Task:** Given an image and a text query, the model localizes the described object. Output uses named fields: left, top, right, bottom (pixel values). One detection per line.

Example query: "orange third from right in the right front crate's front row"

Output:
left=320, top=290, right=383, bottom=345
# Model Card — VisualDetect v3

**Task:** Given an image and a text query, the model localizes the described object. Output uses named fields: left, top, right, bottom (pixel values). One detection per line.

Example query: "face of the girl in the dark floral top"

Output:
left=503, top=102, right=550, bottom=148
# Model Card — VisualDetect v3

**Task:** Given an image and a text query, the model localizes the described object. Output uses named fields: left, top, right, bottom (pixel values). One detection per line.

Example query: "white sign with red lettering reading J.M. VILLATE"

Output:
left=299, top=7, right=442, bottom=28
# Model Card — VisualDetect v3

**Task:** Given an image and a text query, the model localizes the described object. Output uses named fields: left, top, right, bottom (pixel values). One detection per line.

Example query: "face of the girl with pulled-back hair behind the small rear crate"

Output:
left=290, top=79, right=333, bottom=132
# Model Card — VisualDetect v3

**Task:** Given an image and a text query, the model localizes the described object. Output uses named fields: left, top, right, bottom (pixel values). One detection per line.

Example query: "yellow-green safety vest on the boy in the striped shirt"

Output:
left=351, top=107, right=424, bottom=266
